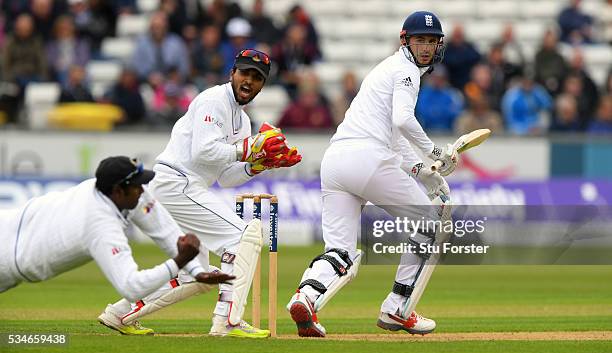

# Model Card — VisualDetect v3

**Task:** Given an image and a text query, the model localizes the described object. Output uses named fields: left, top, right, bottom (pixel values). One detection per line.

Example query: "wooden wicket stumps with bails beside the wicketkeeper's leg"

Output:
left=236, top=194, right=278, bottom=337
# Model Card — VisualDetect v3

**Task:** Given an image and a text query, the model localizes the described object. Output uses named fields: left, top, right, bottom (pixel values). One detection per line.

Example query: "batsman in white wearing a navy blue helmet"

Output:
left=287, top=11, right=457, bottom=337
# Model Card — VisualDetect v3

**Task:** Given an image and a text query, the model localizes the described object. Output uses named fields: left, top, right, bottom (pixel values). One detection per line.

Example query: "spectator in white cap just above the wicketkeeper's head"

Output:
left=221, top=17, right=256, bottom=77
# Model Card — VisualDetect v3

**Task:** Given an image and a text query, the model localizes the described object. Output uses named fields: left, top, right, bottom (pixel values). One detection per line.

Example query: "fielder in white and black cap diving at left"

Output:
left=0, top=156, right=233, bottom=333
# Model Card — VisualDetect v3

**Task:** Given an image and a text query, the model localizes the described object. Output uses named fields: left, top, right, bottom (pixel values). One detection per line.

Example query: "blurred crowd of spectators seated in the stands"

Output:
left=0, top=0, right=612, bottom=135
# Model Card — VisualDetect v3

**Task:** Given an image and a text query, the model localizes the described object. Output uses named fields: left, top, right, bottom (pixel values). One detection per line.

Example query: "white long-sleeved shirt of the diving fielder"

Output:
left=8, top=179, right=204, bottom=301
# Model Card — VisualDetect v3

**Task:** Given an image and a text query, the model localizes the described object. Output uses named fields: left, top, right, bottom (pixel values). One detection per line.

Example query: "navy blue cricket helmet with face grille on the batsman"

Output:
left=400, top=11, right=445, bottom=67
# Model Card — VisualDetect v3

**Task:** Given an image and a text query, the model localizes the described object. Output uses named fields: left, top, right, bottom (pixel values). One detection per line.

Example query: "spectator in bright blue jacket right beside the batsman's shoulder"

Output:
left=414, top=65, right=463, bottom=132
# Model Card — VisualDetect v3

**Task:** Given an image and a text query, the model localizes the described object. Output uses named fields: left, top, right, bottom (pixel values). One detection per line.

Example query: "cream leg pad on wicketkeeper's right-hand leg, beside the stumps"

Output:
left=228, top=219, right=263, bottom=325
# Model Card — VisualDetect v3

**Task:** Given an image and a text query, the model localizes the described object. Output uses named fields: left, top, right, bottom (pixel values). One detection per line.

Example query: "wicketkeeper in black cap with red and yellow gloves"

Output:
left=99, top=49, right=301, bottom=338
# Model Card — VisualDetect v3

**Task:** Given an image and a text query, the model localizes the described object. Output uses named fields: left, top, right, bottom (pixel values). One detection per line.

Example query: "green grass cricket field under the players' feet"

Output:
left=0, top=244, right=612, bottom=353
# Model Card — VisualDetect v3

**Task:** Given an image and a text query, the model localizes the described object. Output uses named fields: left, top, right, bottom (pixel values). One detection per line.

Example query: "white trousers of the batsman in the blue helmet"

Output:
left=305, top=140, right=431, bottom=312
